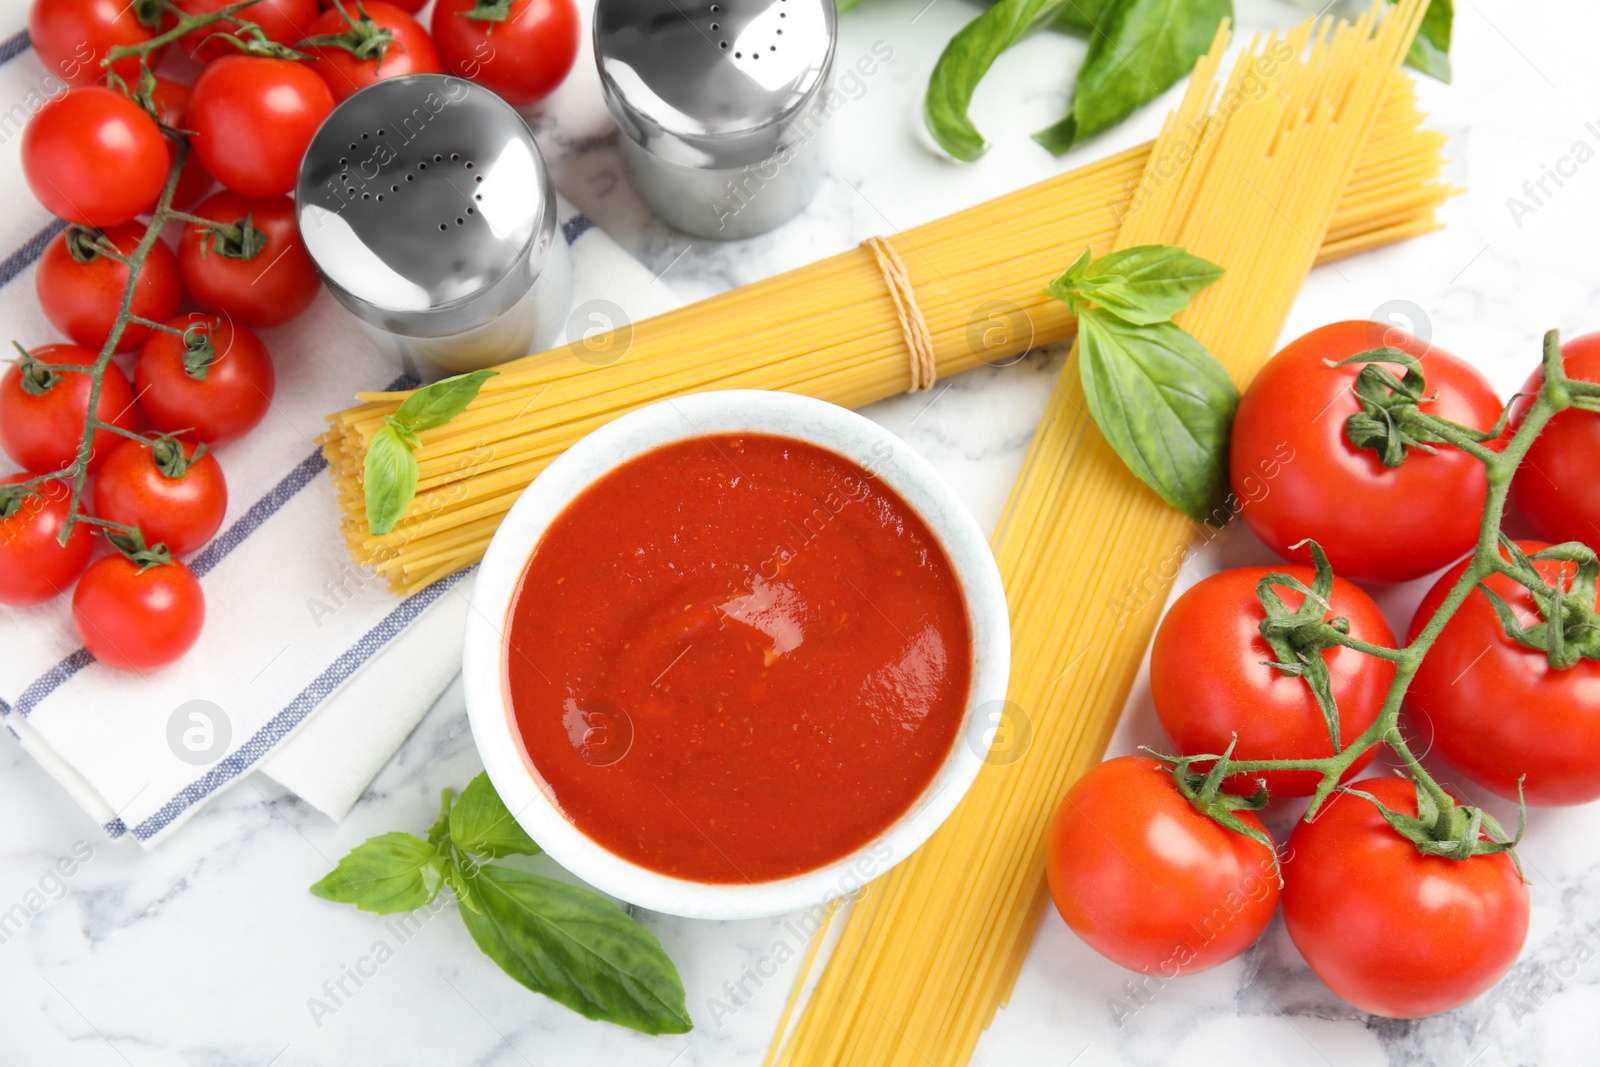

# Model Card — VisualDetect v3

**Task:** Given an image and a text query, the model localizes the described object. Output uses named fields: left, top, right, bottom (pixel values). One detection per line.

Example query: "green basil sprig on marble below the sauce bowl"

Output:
left=310, top=774, right=694, bottom=1033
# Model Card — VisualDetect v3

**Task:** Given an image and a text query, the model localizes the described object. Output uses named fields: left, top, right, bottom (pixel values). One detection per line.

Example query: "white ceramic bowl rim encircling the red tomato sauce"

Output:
left=462, top=390, right=1011, bottom=918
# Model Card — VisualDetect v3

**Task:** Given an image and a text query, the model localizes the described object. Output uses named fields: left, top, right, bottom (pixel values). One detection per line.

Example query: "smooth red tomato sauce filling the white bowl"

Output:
left=507, top=435, right=973, bottom=883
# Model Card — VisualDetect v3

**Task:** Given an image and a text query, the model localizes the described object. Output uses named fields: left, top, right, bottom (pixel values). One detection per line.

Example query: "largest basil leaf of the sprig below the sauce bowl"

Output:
left=461, top=864, right=694, bottom=1033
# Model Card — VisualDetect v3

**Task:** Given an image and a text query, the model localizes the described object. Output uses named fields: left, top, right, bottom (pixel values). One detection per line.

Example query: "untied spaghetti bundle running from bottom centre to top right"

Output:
left=770, top=0, right=1437, bottom=1067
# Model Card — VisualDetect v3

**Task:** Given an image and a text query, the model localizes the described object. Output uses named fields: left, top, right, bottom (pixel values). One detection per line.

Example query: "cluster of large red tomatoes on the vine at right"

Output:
left=1048, top=322, right=1600, bottom=1019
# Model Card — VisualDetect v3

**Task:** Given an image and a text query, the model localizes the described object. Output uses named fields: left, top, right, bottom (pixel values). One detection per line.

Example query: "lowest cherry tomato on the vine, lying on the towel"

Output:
left=72, top=553, right=205, bottom=670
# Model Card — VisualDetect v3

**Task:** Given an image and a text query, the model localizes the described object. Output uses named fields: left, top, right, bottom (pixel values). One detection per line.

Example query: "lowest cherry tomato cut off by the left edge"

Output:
left=0, top=474, right=94, bottom=606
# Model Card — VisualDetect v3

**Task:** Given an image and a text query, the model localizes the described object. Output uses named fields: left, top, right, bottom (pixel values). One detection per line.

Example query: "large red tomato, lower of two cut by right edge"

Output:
left=1406, top=541, right=1600, bottom=805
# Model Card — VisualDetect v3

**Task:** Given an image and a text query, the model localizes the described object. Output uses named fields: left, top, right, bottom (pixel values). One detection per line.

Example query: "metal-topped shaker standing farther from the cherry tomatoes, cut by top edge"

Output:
left=594, top=0, right=837, bottom=238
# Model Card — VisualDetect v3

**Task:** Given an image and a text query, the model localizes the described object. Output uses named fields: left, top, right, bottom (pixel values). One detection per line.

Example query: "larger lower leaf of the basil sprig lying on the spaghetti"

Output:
left=1078, top=307, right=1238, bottom=522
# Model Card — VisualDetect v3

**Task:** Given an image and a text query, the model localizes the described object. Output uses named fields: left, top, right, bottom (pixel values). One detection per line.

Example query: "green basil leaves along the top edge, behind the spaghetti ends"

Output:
left=921, top=0, right=1454, bottom=162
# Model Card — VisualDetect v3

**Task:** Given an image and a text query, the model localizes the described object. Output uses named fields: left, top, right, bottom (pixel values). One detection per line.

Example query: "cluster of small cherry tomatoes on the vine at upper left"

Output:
left=0, top=0, right=578, bottom=670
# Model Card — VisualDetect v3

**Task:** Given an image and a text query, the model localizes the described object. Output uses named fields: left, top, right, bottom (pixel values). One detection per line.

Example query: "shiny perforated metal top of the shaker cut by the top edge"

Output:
left=594, top=0, right=837, bottom=168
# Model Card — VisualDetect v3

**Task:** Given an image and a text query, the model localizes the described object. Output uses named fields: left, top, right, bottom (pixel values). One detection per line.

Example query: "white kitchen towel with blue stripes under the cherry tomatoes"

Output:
left=0, top=22, right=677, bottom=845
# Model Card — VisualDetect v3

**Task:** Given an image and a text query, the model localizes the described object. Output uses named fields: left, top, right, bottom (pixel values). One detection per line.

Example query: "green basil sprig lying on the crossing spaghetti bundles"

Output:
left=1050, top=245, right=1238, bottom=522
